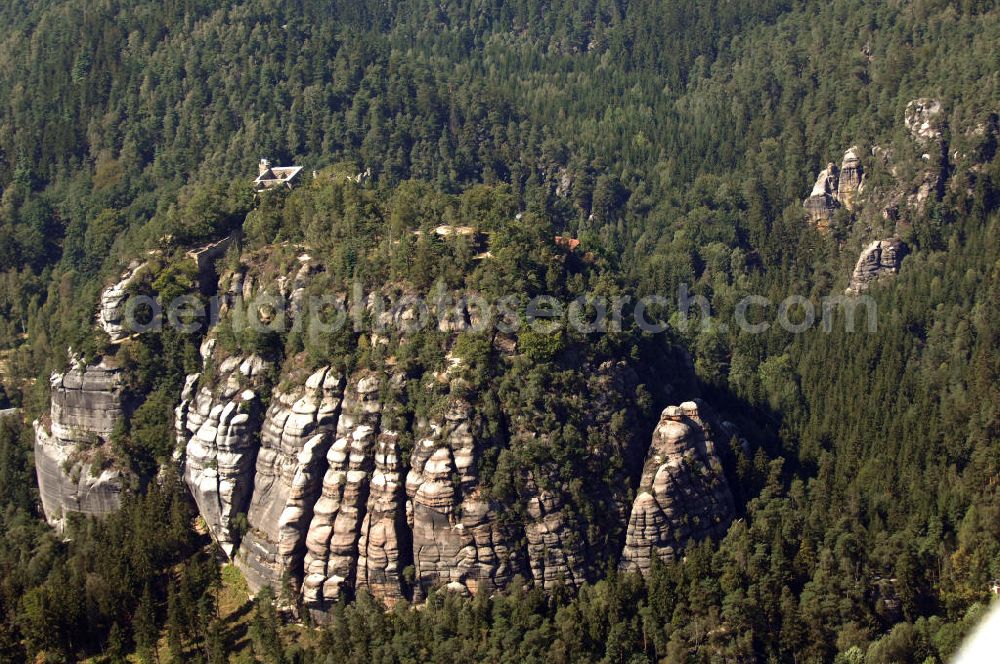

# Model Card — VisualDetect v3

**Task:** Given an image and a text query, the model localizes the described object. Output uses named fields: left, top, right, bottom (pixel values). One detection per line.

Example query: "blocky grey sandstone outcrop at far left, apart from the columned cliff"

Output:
left=34, top=358, right=124, bottom=529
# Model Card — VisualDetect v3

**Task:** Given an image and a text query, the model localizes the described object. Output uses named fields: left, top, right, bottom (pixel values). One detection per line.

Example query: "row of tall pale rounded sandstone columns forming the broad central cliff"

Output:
left=177, top=341, right=672, bottom=622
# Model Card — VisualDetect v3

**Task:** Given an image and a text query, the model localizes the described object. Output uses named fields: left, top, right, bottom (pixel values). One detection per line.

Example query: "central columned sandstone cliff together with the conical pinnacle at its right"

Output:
left=166, top=256, right=733, bottom=621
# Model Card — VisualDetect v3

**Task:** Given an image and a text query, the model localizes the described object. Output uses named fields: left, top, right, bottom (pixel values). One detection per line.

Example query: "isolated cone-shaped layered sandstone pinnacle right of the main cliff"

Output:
left=620, top=401, right=735, bottom=573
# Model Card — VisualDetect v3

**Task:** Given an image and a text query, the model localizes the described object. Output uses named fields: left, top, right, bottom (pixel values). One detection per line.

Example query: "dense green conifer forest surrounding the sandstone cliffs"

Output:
left=0, top=0, right=1000, bottom=663
